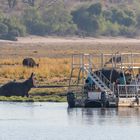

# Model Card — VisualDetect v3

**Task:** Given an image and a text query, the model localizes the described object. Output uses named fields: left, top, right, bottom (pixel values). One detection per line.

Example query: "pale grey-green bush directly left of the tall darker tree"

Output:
left=43, top=1, right=77, bottom=35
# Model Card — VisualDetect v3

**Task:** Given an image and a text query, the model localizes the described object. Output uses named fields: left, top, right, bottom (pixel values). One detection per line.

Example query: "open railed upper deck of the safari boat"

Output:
left=72, top=53, right=140, bottom=70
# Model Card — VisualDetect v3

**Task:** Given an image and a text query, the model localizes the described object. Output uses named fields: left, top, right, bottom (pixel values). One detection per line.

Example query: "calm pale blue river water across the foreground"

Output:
left=0, top=102, right=140, bottom=140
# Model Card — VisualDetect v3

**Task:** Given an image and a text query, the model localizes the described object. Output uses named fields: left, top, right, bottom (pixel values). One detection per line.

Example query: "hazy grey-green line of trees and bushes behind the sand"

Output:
left=0, top=0, right=140, bottom=40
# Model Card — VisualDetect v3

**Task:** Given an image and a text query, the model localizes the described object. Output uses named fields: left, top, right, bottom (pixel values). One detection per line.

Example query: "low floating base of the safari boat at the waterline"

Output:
left=67, top=93, right=140, bottom=108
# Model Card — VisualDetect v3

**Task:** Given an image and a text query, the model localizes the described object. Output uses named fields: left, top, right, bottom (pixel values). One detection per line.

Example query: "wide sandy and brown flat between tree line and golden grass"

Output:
left=0, top=36, right=140, bottom=58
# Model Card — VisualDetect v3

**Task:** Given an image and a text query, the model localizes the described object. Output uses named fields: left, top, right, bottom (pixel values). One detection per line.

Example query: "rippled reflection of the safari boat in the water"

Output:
left=67, top=108, right=140, bottom=126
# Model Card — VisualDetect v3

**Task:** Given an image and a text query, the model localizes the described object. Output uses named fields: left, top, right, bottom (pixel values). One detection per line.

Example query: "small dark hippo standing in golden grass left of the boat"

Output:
left=22, top=58, right=39, bottom=67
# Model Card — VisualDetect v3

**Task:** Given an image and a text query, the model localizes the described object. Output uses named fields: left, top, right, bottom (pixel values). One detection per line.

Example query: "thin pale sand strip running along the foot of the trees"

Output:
left=0, top=36, right=140, bottom=44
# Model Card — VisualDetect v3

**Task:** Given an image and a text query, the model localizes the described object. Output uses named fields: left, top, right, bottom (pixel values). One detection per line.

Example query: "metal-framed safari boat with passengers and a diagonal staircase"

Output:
left=67, top=53, right=140, bottom=107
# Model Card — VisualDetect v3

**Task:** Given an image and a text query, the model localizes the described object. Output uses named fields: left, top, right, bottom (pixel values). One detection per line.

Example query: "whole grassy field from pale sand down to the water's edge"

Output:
left=0, top=37, right=140, bottom=101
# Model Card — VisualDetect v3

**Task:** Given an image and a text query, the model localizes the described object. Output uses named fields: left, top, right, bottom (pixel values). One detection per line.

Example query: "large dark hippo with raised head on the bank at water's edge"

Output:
left=0, top=73, right=35, bottom=97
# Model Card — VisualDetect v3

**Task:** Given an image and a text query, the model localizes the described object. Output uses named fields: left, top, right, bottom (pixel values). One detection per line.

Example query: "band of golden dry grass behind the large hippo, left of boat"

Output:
left=0, top=58, right=70, bottom=83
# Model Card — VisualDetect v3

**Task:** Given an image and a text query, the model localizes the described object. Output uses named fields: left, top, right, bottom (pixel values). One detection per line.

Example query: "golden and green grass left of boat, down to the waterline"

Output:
left=0, top=58, right=70, bottom=102
